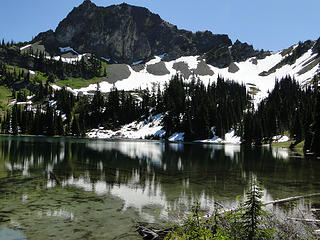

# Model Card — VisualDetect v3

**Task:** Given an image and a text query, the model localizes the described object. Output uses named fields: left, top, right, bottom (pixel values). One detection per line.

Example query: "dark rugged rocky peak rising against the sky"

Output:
left=34, top=0, right=268, bottom=66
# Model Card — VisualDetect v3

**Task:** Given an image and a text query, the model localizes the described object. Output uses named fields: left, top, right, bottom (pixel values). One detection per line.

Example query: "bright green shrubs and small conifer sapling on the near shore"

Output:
left=165, top=181, right=275, bottom=240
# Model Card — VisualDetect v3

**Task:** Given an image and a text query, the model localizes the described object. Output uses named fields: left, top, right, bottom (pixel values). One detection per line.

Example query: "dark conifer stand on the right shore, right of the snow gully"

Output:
left=243, top=76, right=315, bottom=145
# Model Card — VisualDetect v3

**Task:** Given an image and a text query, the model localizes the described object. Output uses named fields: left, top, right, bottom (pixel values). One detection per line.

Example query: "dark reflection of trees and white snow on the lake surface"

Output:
left=0, top=137, right=320, bottom=217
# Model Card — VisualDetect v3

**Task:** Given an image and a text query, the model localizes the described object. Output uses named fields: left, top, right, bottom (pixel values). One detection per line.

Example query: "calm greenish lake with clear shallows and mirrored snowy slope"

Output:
left=0, top=137, right=320, bottom=240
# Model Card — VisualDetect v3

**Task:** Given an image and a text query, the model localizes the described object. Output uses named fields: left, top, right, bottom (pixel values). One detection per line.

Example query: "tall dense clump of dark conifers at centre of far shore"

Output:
left=164, top=75, right=249, bottom=140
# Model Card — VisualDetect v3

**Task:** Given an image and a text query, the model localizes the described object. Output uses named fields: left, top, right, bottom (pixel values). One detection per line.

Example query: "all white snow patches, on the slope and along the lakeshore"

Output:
left=18, top=41, right=320, bottom=144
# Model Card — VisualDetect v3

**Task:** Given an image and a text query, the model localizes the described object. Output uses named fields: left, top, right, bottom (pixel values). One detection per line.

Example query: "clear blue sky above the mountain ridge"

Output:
left=0, top=0, right=320, bottom=51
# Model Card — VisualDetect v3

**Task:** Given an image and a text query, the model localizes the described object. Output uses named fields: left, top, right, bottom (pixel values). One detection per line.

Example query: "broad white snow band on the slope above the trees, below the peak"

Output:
left=69, top=50, right=319, bottom=105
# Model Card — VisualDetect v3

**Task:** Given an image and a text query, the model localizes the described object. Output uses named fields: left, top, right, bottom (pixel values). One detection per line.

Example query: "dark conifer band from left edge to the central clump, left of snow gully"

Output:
left=1, top=75, right=249, bottom=140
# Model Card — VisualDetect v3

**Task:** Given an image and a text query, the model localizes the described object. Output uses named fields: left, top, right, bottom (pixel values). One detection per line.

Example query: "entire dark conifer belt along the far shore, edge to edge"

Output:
left=0, top=65, right=320, bottom=157
